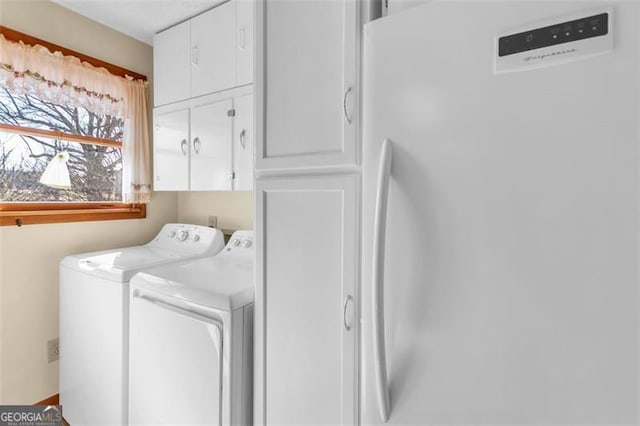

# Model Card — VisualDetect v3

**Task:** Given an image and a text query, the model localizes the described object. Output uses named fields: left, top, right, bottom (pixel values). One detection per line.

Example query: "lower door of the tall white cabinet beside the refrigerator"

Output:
left=254, top=175, right=358, bottom=425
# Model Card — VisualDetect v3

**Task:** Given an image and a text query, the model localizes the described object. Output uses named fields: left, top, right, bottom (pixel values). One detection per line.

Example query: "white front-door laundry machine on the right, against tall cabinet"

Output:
left=129, top=231, right=254, bottom=425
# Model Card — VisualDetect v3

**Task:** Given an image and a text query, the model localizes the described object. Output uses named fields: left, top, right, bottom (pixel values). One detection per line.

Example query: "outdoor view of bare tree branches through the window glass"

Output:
left=0, top=89, right=124, bottom=202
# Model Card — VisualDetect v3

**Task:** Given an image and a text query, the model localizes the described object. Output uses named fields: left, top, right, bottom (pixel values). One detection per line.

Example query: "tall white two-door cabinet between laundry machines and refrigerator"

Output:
left=254, top=0, right=360, bottom=425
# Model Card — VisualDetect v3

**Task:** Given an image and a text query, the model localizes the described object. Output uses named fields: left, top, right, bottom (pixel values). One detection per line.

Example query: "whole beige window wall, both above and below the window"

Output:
left=0, top=0, right=178, bottom=404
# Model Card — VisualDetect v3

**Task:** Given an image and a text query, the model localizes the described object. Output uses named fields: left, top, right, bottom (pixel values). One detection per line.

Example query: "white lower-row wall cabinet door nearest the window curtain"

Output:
left=153, top=108, right=189, bottom=191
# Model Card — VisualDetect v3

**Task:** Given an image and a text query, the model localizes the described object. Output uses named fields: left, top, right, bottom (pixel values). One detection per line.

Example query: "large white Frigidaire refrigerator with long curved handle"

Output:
left=360, top=1, right=640, bottom=425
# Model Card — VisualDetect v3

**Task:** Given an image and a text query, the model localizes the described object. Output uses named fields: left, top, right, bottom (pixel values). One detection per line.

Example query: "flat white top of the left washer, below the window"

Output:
left=60, top=245, right=202, bottom=283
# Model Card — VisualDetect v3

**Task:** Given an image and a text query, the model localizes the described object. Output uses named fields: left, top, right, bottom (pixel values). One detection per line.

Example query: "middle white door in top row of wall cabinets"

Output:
left=191, top=1, right=236, bottom=97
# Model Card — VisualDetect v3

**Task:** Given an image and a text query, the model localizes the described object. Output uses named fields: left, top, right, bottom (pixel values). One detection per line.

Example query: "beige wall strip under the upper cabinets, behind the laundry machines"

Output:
left=178, top=191, right=253, bottom=230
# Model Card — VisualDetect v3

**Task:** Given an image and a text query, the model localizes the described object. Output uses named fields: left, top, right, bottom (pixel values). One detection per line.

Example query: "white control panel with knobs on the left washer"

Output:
left=149, top=223, right=224, bottom=254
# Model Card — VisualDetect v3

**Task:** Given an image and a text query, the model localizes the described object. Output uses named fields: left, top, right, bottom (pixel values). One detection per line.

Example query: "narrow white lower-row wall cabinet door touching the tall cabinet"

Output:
left=233, top=94, right=253, bottom=191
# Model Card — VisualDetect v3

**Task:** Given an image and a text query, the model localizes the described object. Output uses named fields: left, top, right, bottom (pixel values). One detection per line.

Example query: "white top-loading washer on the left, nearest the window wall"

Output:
left=60, top=224, right=224, bottom=426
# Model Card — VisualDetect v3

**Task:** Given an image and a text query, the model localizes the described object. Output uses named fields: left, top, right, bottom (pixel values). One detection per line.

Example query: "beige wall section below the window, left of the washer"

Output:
left=0, top=194, right=177, bottom=404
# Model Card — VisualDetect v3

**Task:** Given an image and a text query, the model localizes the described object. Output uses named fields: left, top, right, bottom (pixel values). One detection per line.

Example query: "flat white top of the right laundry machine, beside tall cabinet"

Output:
left=131, top=256, right=253, bottom=311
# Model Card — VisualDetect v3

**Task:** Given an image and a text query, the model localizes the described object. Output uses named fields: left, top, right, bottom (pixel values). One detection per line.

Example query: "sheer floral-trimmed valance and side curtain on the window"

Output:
left=0, top=34, right=151, bottom=203
